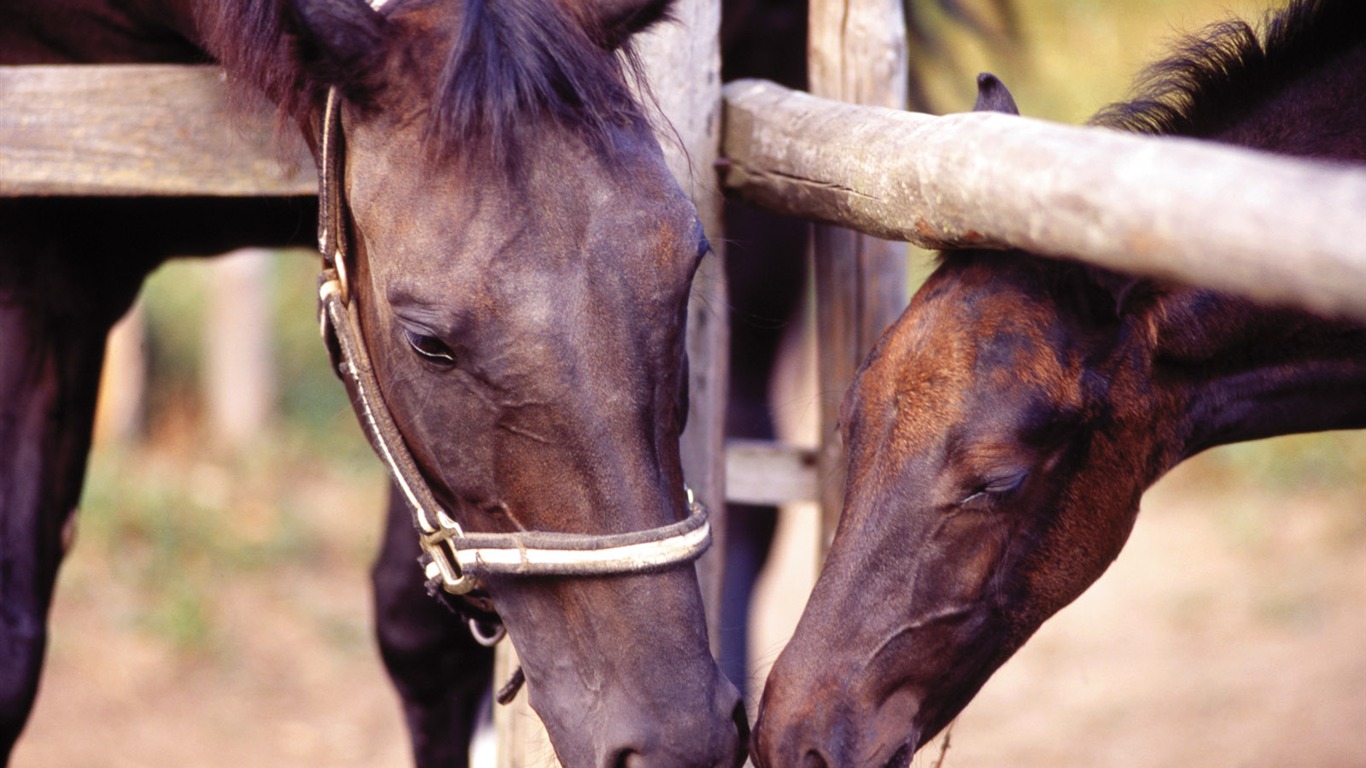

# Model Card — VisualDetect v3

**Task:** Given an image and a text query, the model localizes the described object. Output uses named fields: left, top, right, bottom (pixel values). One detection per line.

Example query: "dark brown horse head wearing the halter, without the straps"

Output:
left=295, top=0, right=744, bottom=767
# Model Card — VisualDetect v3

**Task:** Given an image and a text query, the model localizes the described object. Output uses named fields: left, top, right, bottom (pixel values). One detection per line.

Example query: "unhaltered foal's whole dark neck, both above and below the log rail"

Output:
left=1147, top=26, right=1366, bottom=459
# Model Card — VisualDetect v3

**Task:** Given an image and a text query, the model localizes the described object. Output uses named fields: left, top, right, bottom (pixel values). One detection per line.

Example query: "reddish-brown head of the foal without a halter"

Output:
left=754, top=78, right=1171, bottom=768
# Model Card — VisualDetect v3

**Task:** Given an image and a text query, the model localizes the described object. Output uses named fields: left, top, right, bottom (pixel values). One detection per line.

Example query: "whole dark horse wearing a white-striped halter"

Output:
left=0, top=0, right=746, bottom=767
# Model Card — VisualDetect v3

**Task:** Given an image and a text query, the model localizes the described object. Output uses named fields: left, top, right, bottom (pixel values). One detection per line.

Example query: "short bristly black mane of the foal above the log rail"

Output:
left=1090, top=0, right=1366, bottom=138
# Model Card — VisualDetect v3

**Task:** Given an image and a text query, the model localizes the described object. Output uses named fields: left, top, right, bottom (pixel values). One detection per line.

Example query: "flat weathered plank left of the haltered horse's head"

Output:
left=0, top=64, right=317, bottom=197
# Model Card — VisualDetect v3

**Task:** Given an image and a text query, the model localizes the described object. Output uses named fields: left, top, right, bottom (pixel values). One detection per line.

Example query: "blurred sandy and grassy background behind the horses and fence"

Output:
left=12, top=0, right=1366, bottom=768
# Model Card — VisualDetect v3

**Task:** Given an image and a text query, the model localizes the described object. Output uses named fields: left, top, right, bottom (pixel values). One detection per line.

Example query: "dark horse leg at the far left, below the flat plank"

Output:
left=0, top=228, right=145, bottom=764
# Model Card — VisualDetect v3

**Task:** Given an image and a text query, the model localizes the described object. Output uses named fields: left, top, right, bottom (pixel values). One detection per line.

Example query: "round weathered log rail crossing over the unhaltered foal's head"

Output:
left=721, top=81, right=1366, bottom=321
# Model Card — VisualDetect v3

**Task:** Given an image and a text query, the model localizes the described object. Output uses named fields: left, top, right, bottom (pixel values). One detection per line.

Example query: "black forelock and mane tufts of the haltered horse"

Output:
left=201, top=0, right=646, bottom=164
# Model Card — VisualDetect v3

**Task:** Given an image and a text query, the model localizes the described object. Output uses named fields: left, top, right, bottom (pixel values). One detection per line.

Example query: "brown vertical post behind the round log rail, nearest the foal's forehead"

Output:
left=807, top=0, right=907, bottom=553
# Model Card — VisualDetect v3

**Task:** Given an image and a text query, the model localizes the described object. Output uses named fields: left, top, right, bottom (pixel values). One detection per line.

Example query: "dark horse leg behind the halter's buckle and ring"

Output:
left=372, top=486, right=493, bottom=768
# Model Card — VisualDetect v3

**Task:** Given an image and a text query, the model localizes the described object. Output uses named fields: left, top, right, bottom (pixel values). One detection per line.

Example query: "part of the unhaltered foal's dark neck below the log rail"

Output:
left=1152, top=290, right=1366, bottom=465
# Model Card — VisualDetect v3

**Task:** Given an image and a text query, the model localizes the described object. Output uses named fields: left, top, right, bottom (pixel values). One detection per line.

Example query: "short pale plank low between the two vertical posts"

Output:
left=725, top=439, right=820, bottom=506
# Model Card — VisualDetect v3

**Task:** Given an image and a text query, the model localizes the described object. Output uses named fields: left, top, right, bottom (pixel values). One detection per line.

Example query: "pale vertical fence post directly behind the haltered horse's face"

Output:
left=494, top=0, right=728, bottom=768
